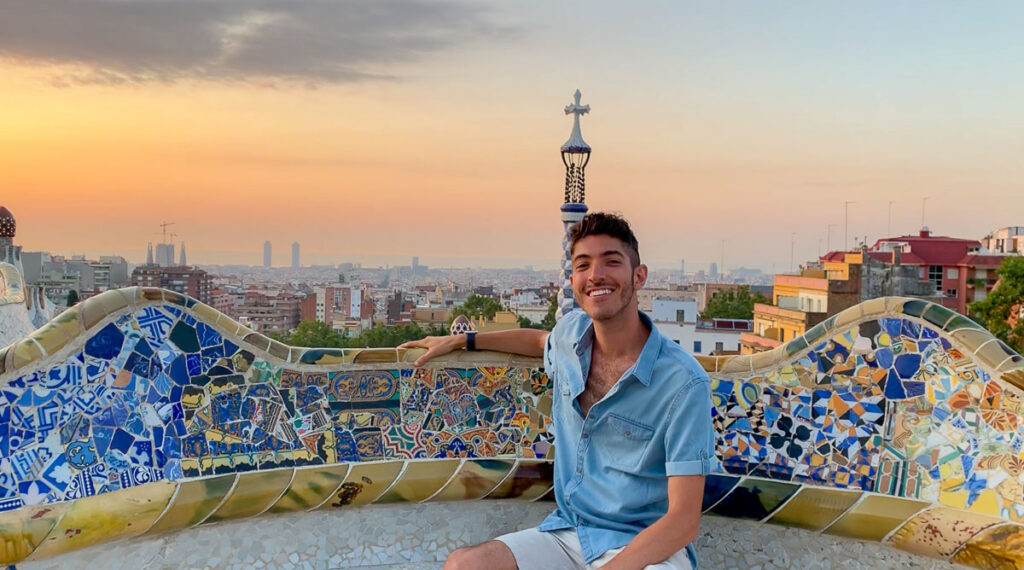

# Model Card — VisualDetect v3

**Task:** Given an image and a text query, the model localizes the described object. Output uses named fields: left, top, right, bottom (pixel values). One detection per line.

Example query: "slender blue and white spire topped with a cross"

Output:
left=555, top=89, right=590, bottom=318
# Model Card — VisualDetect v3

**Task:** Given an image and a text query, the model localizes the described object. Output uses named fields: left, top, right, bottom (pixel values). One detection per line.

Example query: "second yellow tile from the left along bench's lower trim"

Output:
left=28, top=481, right=175, bottom=560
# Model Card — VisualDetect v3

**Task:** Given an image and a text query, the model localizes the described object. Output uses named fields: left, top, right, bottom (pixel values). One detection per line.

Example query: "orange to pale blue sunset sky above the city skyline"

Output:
left=0, top=0, right=1024, bottom=271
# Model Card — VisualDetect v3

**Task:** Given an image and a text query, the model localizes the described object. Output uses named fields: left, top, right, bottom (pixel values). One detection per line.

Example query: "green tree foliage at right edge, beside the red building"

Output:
left=968, top=257, right=1024, bottom=352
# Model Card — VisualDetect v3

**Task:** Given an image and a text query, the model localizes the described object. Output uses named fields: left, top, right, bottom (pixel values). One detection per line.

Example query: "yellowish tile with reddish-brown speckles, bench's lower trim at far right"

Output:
left=889, top=507, right=1001, bottom=558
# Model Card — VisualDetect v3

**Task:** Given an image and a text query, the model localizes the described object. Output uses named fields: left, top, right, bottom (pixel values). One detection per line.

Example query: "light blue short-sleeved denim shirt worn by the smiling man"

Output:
left=540, top=310, right=715, bottom=568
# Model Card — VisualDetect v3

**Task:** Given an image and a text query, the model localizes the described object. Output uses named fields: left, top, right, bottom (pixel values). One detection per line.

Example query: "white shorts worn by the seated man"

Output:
left=495, top=528, right=693, bottom=570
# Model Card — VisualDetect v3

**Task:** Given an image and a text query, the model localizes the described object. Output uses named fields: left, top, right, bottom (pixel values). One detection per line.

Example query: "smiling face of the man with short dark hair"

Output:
left=572, top=235, right=647, bottom=320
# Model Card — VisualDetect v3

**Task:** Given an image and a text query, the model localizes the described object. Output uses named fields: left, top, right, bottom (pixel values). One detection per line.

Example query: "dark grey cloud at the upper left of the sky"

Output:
left=0, top=0, right=510, bottom=86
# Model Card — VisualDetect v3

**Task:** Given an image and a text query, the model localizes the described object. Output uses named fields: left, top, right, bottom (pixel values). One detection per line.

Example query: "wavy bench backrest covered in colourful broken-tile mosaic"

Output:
left=0, top=288, right=1024, bottom=567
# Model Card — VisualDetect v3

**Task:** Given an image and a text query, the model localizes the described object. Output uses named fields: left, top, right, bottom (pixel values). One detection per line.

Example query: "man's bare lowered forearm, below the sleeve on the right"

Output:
left=601, top=512, right=700, bottom=570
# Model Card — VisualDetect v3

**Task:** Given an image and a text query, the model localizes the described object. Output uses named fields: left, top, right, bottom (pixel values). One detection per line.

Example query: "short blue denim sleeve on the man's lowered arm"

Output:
left=665, top=376, right=715, bottom=477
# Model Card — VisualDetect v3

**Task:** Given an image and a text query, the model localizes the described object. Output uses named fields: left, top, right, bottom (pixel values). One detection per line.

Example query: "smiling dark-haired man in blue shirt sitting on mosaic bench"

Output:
left=399, top=213, right=715, bottom=570
